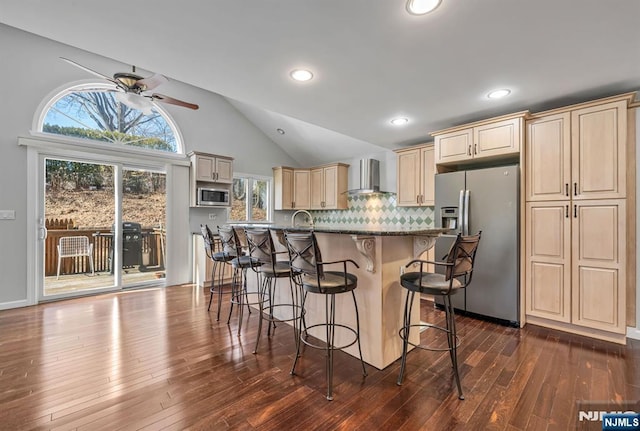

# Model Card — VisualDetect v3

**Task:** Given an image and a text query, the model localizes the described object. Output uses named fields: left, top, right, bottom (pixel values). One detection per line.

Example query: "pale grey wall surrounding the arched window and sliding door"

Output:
left=0, top=24, right=296, bottom=309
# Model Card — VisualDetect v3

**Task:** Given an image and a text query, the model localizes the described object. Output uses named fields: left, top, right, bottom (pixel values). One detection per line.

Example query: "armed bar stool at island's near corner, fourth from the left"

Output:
left=284, top=231, right=367, bottom=401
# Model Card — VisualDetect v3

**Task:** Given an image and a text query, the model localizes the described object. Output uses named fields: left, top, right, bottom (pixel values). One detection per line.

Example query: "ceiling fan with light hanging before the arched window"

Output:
left=60, top=57, right=199, bottom=115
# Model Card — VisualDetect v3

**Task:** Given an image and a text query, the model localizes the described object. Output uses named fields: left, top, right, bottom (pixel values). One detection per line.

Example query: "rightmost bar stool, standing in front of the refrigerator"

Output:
left=397, top=231, right=482, bottom=400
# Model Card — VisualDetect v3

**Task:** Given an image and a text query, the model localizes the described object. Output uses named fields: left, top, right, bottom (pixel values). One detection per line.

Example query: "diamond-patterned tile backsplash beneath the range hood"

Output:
left=311, top=193, right=435, bottom=229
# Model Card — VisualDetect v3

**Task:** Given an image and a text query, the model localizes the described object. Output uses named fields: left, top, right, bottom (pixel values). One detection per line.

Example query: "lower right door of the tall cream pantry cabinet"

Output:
left=572, top=199, right=626, bottom=334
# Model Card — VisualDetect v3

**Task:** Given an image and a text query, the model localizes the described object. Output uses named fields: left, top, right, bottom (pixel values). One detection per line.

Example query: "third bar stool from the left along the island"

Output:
left=245, top=228, right=303, bottom=353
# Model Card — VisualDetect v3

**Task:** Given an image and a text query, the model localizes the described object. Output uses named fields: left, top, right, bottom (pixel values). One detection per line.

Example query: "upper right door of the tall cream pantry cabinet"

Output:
left=571, top=101, right=627, bottom=199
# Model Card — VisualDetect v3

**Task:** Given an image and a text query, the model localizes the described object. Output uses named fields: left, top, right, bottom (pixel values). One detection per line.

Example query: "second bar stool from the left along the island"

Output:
left=218, top=226, right=260, bottom=335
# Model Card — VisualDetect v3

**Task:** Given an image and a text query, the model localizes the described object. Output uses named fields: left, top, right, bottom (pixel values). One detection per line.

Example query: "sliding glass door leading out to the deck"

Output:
left=38, top=156, right=166, bottom=299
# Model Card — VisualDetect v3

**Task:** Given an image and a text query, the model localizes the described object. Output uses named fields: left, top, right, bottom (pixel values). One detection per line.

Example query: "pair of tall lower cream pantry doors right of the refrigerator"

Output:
left=525, top=199, right=626, bottom=342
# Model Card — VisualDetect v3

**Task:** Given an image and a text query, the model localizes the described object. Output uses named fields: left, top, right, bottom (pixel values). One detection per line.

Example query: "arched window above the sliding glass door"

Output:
left=37, top=83, right=184, bottom=154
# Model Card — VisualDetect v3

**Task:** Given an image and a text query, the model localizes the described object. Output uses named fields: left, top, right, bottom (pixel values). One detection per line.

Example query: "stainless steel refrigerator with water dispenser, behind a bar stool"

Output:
left=434, top=165, right=520, bottom=326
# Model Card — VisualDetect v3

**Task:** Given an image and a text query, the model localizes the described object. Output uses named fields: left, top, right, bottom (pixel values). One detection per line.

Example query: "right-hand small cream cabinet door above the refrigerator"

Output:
left=472, top=118, right=522, bottom=158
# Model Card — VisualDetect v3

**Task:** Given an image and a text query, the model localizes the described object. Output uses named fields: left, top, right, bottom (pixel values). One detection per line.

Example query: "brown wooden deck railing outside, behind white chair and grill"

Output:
left=44, top=228, right=164, bottom=276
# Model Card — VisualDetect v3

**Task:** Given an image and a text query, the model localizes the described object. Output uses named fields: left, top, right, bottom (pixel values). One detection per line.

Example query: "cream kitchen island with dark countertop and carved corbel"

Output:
left=242, top=225, right=448, bottom=369
